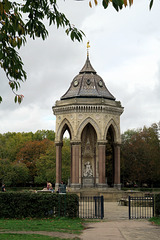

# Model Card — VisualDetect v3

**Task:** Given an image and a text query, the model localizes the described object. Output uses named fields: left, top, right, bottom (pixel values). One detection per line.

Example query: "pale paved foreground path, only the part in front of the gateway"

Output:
left=81, top=220, right=160, bottom=240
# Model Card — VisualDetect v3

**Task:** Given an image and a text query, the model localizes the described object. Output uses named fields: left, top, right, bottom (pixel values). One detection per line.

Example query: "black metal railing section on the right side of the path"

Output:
left=129, top=195, right=154, bottom=219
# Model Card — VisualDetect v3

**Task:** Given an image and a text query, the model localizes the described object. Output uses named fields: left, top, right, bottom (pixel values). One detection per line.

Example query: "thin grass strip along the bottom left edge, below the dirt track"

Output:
left=0, top=233, right=79, bottom=240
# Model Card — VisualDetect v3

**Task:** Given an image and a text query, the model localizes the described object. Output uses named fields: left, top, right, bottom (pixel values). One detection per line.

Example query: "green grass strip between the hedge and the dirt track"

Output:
left=0, top=218, right=84, bottom=234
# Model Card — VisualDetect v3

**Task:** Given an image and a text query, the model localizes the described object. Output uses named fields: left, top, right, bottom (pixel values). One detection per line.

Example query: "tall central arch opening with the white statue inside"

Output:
left=81, top=123, right=97, bottom=187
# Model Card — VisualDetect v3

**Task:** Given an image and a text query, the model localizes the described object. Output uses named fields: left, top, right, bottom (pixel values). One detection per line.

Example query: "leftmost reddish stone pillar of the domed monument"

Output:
left=55, top=142, right=63, bottom=190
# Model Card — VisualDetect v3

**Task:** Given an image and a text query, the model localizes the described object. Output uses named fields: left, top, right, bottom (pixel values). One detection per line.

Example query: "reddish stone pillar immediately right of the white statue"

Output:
left=97, top=142, right=107, bottom=188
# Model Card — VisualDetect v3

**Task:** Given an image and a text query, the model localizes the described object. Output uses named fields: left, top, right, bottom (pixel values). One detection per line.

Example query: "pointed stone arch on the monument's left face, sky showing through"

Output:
left=57, top=118, right=74, bottom=141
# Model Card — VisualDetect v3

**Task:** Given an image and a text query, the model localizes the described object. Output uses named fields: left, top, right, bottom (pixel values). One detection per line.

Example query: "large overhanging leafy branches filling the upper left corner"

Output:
left=0, top=0, right=84, bottom=103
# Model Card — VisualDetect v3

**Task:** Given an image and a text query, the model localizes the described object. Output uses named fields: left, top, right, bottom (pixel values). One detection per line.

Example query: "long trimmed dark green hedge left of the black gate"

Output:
left=0, top=192, right=79, bottom=218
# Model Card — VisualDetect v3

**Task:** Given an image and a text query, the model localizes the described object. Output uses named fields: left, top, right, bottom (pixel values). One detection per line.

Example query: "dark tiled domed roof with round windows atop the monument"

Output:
left=61, top=55, right=115, bottom=100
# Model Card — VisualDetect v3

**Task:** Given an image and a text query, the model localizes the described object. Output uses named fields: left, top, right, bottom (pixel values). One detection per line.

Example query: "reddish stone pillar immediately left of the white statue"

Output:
left=71, top=142, right=80, bottom=189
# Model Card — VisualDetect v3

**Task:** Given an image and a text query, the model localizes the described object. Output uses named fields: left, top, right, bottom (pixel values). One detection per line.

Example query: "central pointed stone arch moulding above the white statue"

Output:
left=77, top=117, right=101, bottom=140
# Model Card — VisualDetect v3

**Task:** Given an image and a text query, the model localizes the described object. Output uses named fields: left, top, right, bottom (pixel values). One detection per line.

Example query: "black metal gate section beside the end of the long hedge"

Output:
left=79, top=196, right=104, bottom=219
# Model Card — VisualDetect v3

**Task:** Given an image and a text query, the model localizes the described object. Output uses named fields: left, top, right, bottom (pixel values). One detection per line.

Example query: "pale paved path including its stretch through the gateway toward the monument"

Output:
left=80, top=203, right=160, bottom=240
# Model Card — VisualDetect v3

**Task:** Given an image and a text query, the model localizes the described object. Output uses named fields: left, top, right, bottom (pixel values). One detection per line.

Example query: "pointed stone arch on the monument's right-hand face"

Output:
left=104, top=118, right=120, bottom=143
